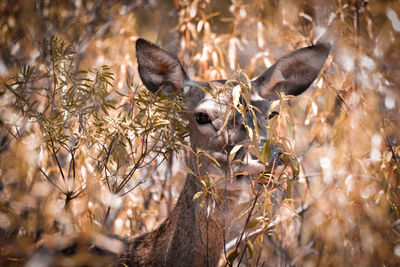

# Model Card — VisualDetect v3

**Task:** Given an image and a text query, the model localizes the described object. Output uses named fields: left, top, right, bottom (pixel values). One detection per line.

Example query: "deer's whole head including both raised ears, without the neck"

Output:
left=136, top=39, right=330, bottom=183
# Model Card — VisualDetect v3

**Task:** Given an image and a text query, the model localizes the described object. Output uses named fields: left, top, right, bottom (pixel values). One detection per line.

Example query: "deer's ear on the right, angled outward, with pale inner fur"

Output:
left=252, top=43, right=331, bottom=100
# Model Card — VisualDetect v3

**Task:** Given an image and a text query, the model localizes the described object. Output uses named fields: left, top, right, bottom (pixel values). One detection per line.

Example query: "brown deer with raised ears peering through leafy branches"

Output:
left=120, top=38, right=331, bottom=266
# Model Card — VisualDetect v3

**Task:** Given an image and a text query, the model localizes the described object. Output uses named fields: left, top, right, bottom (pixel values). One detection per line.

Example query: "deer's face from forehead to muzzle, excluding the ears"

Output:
left=180, top=80, right=270, bottom=178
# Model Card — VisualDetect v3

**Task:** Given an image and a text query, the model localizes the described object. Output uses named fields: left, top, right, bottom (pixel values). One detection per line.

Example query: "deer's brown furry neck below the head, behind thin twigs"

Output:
left=126, top=175, right=236, bottom=266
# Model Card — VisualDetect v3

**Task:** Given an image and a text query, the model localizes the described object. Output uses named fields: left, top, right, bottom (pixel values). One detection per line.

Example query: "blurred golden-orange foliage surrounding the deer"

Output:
left=0, top=0, right=400, bottom=266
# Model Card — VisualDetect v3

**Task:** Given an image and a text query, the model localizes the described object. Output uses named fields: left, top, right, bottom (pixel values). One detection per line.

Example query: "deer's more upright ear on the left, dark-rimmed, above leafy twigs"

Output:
left=136, top=38, right=190, bottom=94
